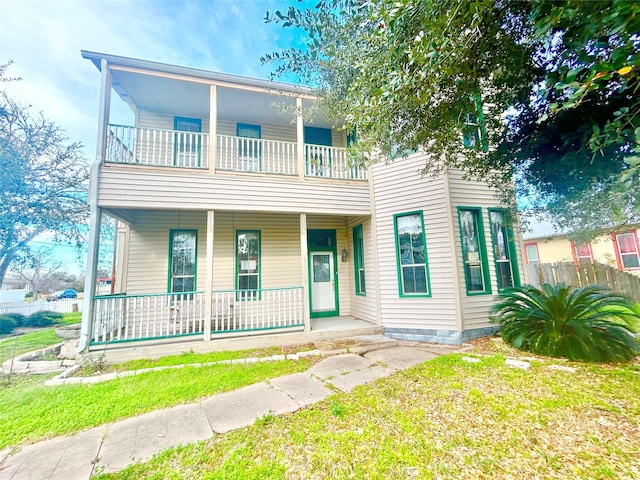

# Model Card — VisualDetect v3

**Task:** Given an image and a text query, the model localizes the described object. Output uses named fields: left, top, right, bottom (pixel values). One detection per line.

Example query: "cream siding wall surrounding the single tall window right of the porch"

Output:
left=372, top=154, right=458, bottom=331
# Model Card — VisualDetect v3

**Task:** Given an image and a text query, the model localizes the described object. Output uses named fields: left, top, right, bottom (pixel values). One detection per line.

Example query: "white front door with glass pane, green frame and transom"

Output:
left=308, top=230, right=339, bottom=318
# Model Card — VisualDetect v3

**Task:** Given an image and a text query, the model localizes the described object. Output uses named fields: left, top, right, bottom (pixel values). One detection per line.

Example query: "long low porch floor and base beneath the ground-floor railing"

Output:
left=90, top=316, right=383, bottom=363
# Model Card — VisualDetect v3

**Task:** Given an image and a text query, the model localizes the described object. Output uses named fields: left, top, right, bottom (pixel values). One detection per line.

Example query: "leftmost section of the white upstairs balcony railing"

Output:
left=105, top=125, right=209, bottom=168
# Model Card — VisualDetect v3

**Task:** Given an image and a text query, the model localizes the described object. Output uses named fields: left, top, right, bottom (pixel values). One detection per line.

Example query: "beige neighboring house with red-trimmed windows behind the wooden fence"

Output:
left=523, top=219, right=640, bottom=275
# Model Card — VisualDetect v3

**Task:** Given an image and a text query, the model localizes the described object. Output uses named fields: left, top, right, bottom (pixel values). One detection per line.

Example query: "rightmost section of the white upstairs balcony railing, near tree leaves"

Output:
left=304, top=143, right=367, bottom=180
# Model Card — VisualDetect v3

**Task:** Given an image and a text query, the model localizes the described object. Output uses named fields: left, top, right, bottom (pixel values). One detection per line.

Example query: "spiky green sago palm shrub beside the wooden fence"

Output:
left=492, top=283, right=640, bottom=362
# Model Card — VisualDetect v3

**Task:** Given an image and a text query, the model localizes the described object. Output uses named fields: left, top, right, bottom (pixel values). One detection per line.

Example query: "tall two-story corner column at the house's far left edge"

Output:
left=77, top=58, right=111, bottom=352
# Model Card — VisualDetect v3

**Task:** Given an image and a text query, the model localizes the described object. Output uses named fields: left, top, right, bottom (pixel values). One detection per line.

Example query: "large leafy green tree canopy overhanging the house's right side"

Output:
left=263, top=0, right=640, bottom=236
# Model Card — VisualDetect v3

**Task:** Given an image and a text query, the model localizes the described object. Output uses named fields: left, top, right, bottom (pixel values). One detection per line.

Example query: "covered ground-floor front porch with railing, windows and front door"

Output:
left=82, top=210, right=378, bottom=348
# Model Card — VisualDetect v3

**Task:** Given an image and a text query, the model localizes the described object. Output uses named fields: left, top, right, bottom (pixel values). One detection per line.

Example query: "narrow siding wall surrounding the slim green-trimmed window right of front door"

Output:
left=347, top=217, right=379, bottom=323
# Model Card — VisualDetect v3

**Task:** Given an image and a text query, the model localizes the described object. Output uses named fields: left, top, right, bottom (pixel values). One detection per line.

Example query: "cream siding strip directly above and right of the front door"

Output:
left=307, top=215, right=353, bottom=315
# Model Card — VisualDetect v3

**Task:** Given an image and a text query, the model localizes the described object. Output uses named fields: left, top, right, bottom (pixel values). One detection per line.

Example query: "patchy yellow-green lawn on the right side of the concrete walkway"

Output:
left=98, top=352, right=640, bottom=479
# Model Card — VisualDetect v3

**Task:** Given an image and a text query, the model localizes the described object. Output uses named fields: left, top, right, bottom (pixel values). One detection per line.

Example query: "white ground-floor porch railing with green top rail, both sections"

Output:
left=91, top=287, right=304, bottom=344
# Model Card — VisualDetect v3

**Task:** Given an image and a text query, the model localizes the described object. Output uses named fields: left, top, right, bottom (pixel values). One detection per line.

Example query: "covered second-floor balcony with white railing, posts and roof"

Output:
left=83, top=52, right=368, bottom=185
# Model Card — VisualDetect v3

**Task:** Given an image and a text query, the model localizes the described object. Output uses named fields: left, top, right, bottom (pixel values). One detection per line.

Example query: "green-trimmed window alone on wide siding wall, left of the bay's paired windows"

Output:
left=393, top=212, right=431, bottom=297
